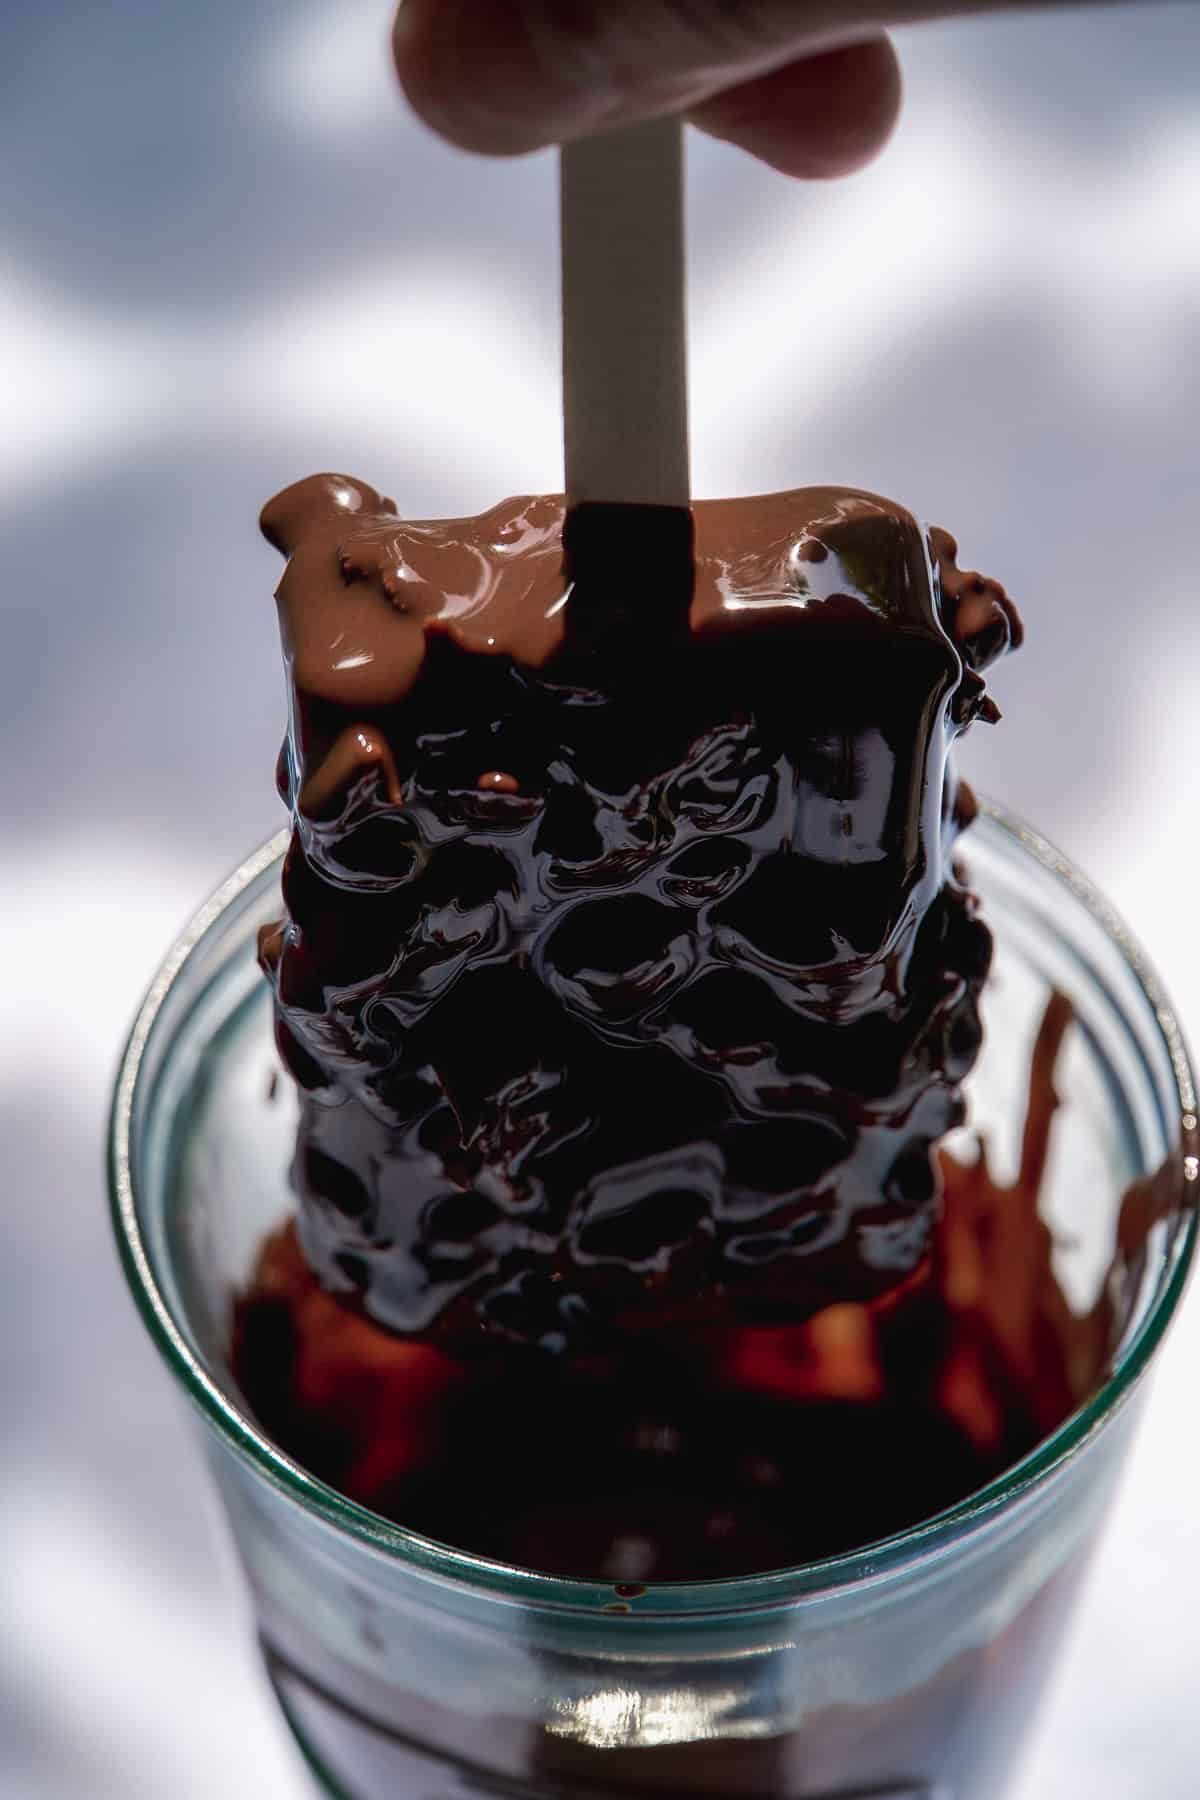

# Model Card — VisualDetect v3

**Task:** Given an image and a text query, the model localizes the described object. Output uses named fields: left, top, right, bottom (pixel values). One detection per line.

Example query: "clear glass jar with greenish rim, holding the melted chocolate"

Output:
left=112, top=808, right=1198, bottom=1800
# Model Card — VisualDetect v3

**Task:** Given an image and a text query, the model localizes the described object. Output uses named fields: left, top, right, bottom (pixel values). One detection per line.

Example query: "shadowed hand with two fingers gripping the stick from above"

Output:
left=394, top=0, right=1072, bottom=176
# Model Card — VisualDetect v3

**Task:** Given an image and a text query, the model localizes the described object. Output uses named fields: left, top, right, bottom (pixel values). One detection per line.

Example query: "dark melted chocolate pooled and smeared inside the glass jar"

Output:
left=234, top=997, right=1137, bottom=1597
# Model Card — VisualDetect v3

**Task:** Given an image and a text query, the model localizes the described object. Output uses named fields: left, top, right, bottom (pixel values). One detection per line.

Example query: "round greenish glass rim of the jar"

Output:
left=108, top=799, right=1200, bottom=1622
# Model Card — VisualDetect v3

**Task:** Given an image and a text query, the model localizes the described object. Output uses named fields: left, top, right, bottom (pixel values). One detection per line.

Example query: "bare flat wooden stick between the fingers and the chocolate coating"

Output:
left=560, top=119, right=691, bottom=508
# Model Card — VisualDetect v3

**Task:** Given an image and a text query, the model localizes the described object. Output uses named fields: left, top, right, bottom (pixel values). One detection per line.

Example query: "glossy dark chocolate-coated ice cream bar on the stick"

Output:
left=263, top=475, right=1020, bottom=1354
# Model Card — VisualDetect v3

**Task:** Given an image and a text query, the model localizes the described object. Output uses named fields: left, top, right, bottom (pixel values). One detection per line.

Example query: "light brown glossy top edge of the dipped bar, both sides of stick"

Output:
left=261, top=473, right=1018, bottom=718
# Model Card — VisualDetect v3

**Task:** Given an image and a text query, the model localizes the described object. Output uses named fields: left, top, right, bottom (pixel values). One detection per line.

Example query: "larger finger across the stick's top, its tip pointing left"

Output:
left=394, top=0, right=1031, bottom=166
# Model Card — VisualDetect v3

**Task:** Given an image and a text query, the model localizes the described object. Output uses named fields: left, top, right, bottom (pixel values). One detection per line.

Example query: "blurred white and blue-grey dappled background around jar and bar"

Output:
left=0, top=0, right=1200, bottom=1800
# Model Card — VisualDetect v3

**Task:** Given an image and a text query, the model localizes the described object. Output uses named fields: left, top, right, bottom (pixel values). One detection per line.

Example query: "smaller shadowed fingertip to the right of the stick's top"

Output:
left=689, top=38, right=901, bottom=180
